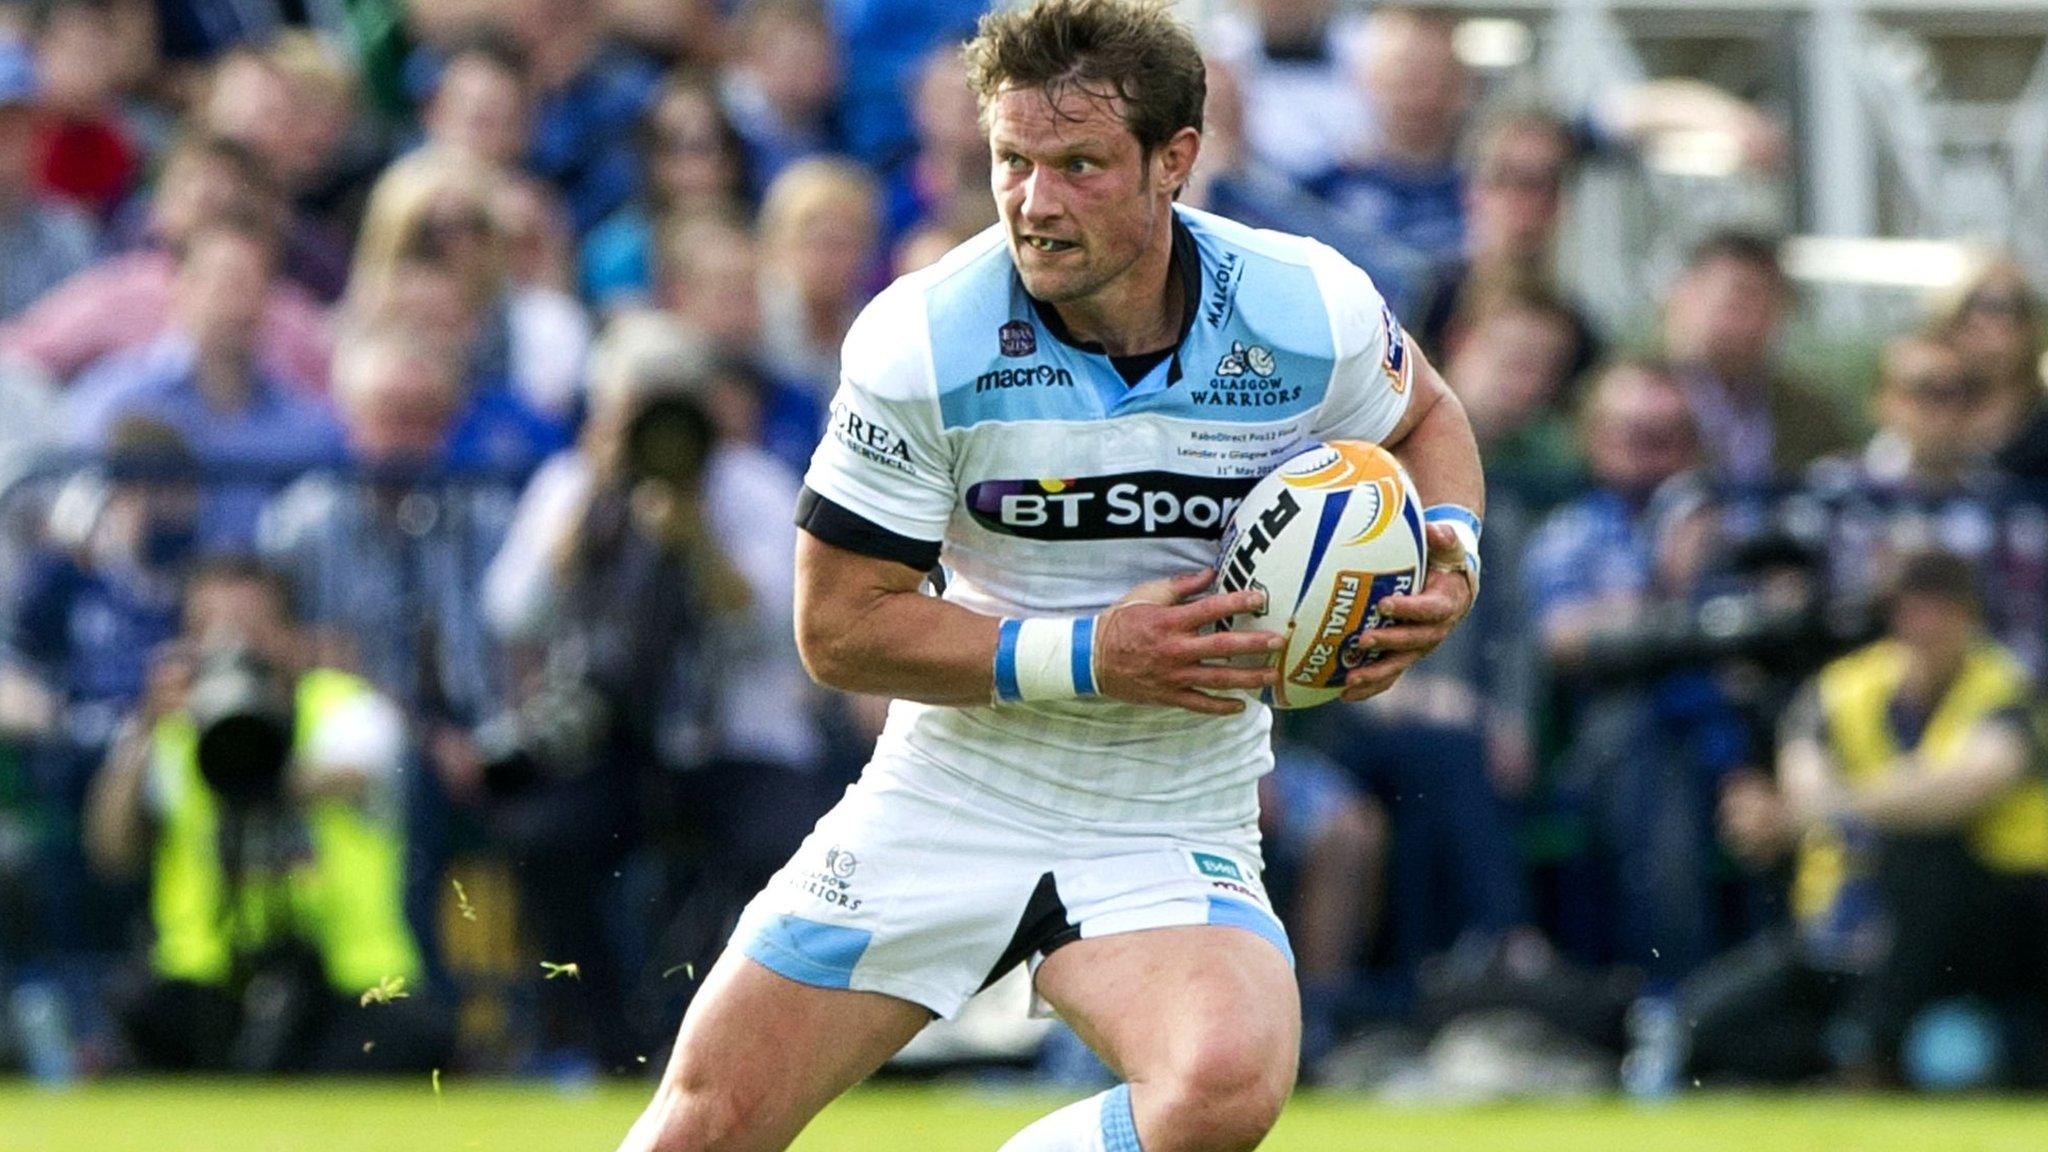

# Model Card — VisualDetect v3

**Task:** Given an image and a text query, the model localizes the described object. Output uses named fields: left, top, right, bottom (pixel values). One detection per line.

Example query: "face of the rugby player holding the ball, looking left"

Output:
left=989, top=88, right=1171, bottom=303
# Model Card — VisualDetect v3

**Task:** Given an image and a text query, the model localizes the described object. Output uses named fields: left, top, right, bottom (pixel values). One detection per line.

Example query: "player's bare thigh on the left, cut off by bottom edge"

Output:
left=621, top=949, right=932, bottom=1152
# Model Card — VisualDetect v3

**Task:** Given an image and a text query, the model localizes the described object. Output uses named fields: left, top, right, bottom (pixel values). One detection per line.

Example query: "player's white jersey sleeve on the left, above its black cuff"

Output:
left=803, top=283, right=958, bottom=543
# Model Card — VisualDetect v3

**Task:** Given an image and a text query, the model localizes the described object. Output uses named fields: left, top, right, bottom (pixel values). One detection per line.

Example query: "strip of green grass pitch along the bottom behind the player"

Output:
left=0, top=1078, right=2048, bottom=1152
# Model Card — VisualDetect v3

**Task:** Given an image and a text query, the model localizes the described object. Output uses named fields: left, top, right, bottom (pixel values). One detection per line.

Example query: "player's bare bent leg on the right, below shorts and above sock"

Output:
left=1036, top=924, right=1300, bottom=1148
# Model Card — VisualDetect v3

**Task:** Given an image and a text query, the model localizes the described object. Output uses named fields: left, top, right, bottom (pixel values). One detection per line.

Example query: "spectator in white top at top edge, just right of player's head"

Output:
left=1206, top=0, right=1372, bottom=180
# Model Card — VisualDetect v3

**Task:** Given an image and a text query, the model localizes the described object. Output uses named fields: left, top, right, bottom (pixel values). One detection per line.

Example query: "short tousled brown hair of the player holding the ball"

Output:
left=965, top=0, right=1208, bottom=152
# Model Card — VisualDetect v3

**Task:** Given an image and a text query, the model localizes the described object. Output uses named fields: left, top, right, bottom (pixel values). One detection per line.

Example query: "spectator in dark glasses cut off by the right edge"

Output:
left=1929, top=256, right=2048, bottom=480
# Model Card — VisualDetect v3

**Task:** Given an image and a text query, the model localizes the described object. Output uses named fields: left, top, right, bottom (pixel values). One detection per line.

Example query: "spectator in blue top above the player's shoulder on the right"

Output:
left=1307, top=8, right=1475, bottom=299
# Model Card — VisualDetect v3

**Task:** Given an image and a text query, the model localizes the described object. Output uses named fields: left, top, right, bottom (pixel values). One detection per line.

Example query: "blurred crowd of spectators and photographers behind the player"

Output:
left=0, top=0, right=2048, bottom=1093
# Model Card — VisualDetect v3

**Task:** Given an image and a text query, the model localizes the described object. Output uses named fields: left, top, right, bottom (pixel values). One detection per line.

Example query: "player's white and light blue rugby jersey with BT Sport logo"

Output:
left=799, top=207, right=1409, bottom=830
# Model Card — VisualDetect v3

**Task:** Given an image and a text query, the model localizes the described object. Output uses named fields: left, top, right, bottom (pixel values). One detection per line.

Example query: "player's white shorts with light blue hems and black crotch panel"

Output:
left=733, top=765, right=1294, bottom=1019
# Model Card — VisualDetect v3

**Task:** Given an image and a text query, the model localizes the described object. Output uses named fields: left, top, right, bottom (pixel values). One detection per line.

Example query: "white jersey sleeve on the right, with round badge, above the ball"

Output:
left=1309, top=244, right=1415, bottom=443
